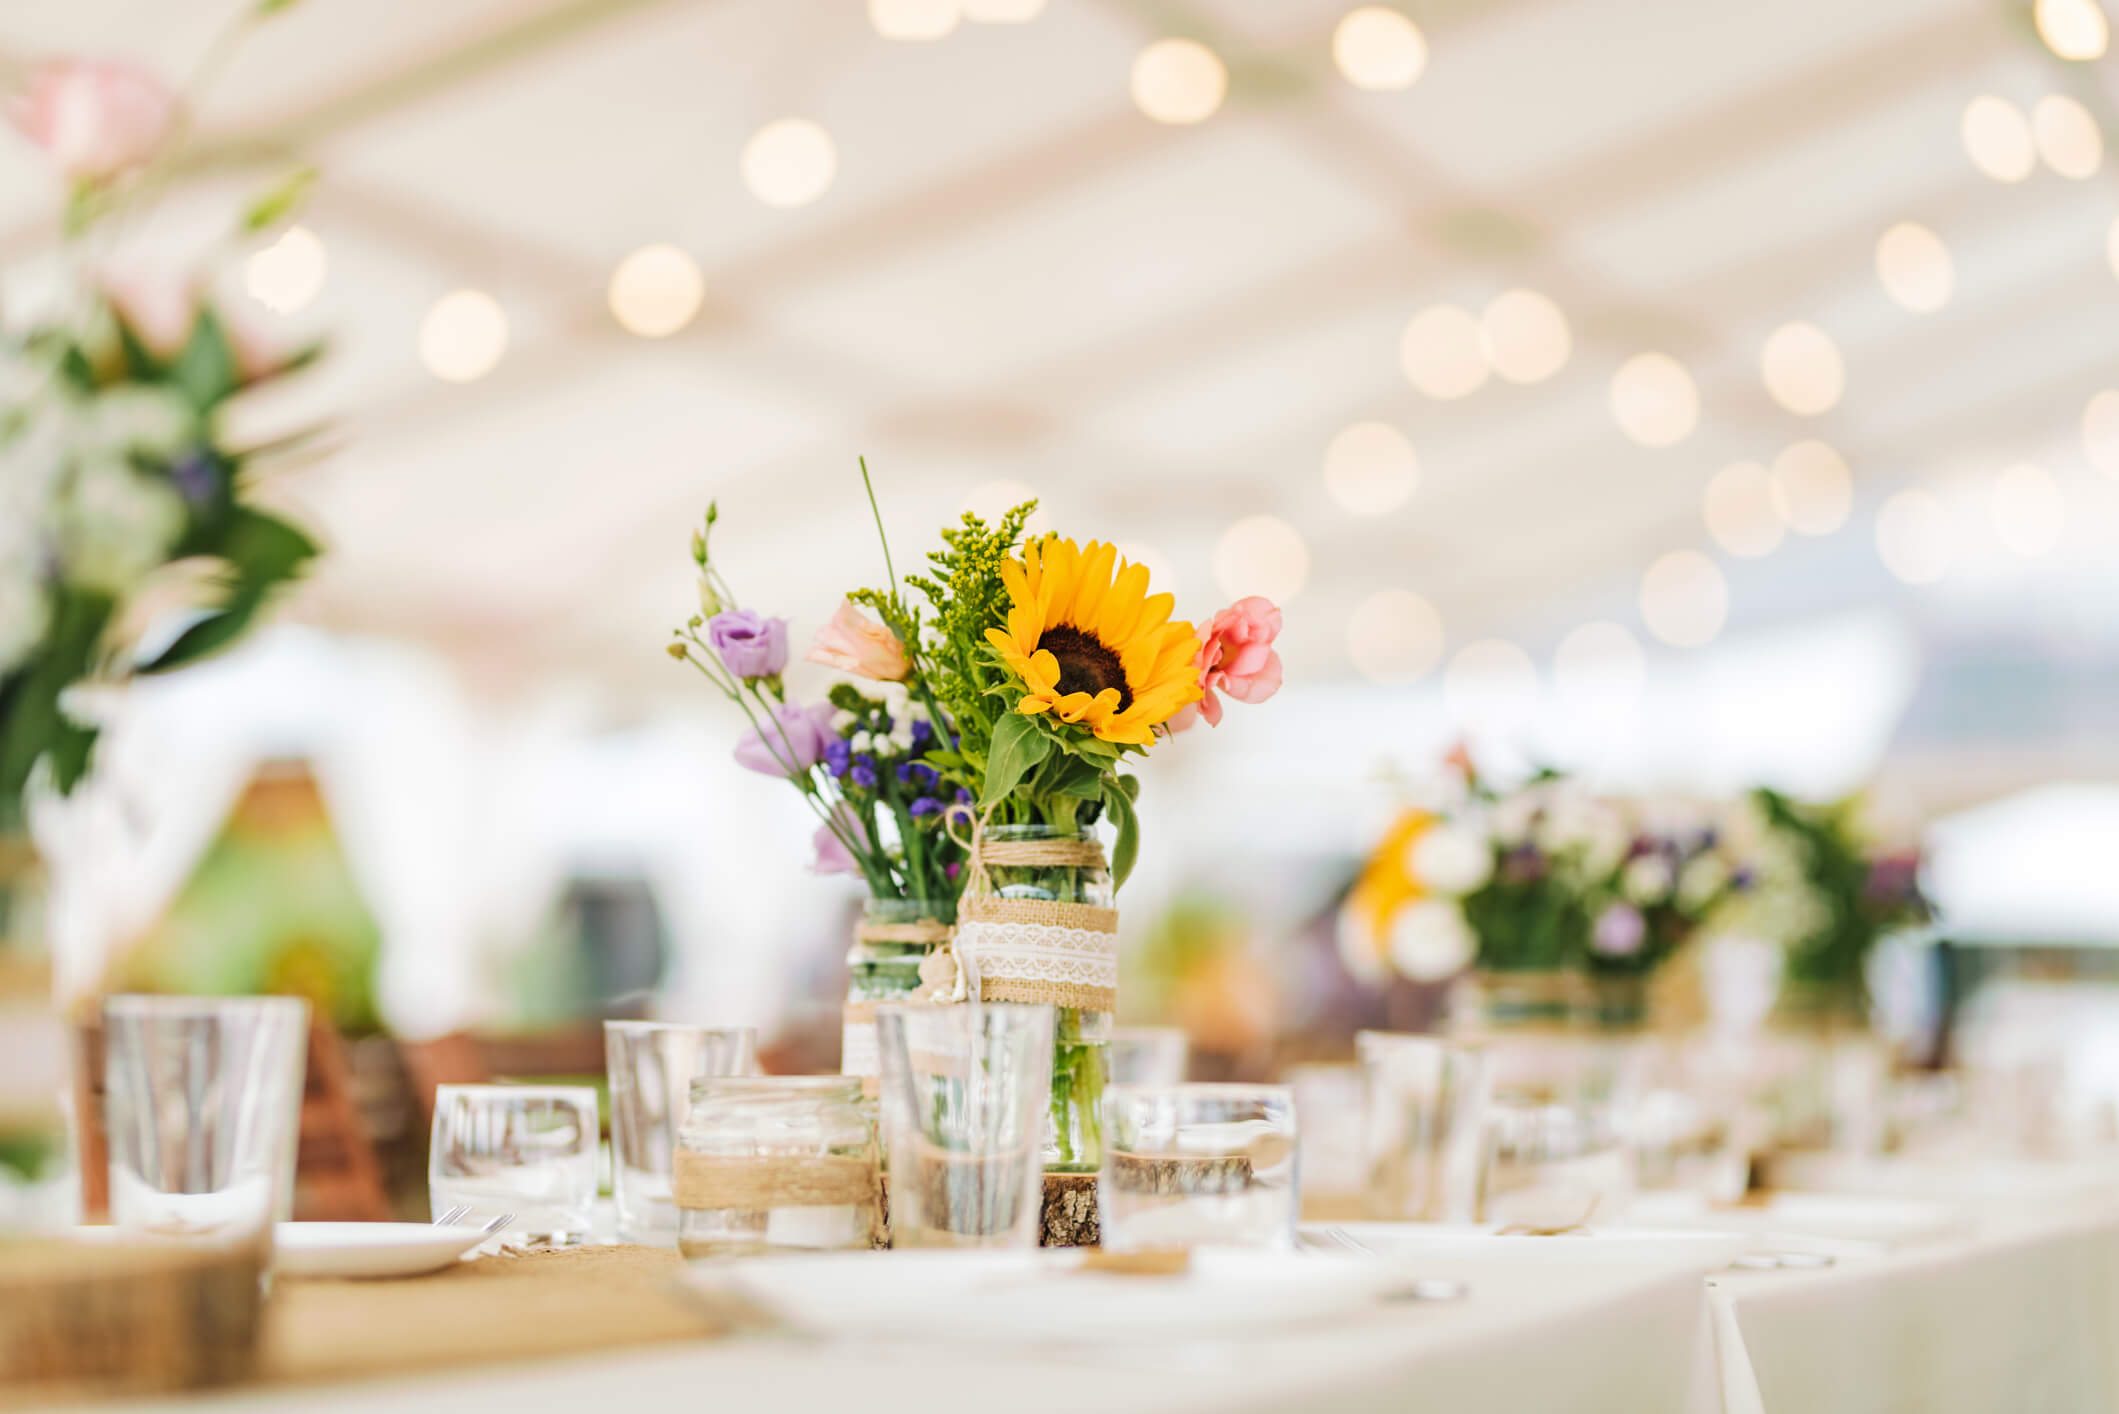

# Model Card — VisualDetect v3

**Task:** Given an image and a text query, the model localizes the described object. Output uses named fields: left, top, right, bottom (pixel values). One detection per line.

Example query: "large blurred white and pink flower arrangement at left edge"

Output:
left=0, top=0, right=318, bottom=1225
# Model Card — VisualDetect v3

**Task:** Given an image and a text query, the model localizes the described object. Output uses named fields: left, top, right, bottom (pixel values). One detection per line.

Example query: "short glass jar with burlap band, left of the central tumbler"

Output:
left=674, top=1075, right=879, bottom=1257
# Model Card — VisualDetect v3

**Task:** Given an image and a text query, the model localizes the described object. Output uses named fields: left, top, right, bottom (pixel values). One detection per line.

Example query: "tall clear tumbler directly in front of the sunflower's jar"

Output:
left=875, top=1003, right=1053, bottom=1247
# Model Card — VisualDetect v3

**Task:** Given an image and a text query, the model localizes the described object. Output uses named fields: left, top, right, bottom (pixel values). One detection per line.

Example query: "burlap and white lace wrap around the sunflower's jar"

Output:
left=918, top=820, right=1119, bottom=1011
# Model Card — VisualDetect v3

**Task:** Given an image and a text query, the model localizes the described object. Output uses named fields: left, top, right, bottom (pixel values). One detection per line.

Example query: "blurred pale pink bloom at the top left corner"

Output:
left=8, top=59, right=176, bottom=182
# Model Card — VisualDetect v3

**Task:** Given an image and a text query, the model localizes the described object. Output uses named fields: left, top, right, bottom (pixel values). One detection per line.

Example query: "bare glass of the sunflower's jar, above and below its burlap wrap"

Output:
left=985, top=825, right=1112, bottom=1174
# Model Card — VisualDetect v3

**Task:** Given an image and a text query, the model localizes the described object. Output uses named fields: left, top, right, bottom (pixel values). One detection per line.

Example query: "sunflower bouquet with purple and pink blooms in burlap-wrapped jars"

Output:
left=670, top=464, right=1280, bottom=1172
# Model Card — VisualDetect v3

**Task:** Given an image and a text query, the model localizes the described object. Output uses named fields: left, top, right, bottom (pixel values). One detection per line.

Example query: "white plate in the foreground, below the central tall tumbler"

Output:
left=687, top=1249, right=1405, bottom=1342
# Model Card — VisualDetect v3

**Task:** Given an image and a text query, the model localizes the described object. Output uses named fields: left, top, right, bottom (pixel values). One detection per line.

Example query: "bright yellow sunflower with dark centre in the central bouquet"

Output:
left=985, top=534, right=1199, bottom=746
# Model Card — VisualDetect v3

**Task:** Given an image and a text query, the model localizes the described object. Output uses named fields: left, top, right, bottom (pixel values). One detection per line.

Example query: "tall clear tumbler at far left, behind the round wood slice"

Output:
left=104, top=996, right=309, bottom=1240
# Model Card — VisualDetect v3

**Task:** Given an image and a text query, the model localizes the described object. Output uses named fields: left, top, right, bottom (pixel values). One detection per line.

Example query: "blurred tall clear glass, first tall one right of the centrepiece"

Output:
left=1354, top=1030, right=1488, bottom=1223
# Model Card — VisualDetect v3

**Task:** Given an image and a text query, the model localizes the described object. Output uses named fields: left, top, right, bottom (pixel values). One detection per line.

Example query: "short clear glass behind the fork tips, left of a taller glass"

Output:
left=426, top=1085, right=600, bottom=1247
